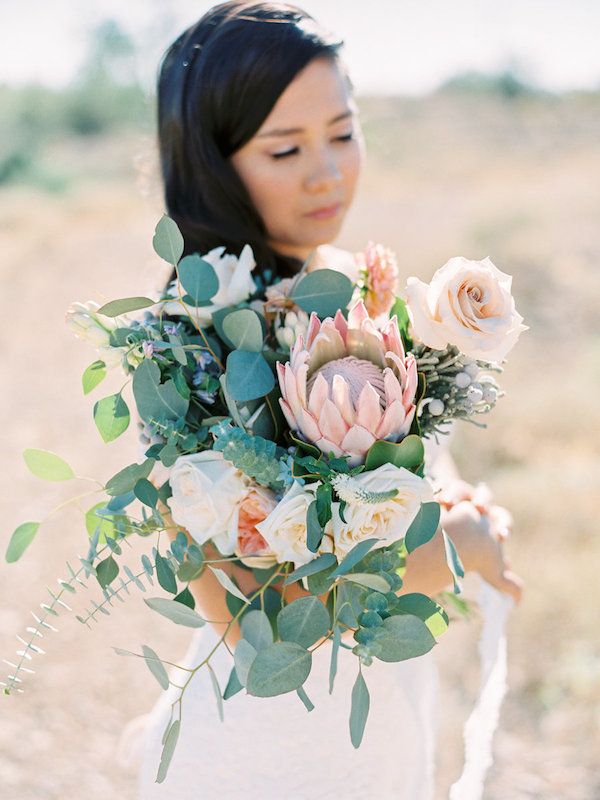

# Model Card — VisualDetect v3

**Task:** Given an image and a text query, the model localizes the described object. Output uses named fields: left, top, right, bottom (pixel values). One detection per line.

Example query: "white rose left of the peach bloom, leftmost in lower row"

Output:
left=167, top=450, right=250, bottom=555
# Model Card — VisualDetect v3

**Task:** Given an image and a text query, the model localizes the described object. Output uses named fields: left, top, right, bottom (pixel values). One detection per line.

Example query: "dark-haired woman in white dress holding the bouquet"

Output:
left=140, top=0, right=519, bottom=800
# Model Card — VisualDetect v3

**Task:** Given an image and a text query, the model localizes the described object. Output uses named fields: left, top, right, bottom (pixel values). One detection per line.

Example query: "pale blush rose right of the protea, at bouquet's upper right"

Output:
left=405, top=256, right=527, bottom=362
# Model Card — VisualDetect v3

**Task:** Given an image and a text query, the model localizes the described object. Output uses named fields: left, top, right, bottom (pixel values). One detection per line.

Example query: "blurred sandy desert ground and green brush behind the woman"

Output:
left=0, top=7, right=600, bottom=800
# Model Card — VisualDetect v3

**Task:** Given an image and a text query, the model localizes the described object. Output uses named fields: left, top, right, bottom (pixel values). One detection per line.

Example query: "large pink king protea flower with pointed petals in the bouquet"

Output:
left=277, top=300, right=417, bottom=465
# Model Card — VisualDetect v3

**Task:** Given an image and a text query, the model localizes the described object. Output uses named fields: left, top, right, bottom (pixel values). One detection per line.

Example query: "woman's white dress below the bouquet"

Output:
left=134, top=438, right=442, bottom=800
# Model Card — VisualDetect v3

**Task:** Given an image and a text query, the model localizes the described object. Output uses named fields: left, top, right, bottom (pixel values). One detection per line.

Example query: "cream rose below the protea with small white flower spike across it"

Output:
left=333, top=464, right=433, bottom=560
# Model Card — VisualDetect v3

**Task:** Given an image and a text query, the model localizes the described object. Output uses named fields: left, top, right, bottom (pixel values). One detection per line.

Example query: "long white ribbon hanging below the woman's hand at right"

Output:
left=449, top=581, right=514, bottom=800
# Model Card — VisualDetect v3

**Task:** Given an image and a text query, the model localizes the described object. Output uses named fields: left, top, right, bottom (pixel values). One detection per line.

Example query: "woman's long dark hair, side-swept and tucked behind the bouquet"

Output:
left=158, top=0, right=342, bottom=284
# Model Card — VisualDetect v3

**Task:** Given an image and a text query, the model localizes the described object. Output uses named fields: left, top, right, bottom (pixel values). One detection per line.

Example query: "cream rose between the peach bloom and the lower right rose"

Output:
left=256, top=481, right=331, bottom=567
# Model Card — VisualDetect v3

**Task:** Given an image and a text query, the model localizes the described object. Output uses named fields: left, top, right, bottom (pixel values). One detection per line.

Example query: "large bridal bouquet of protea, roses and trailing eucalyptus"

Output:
left=4, top=216, right=524, bottom=780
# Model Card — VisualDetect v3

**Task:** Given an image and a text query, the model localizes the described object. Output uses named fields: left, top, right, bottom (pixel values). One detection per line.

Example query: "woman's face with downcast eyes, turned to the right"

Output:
left=231, top=57, right=363, bottom=261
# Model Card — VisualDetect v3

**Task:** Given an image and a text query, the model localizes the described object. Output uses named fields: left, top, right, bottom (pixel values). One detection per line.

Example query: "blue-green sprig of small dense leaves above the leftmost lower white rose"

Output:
left=210, top=424, right=282, bottom=489
